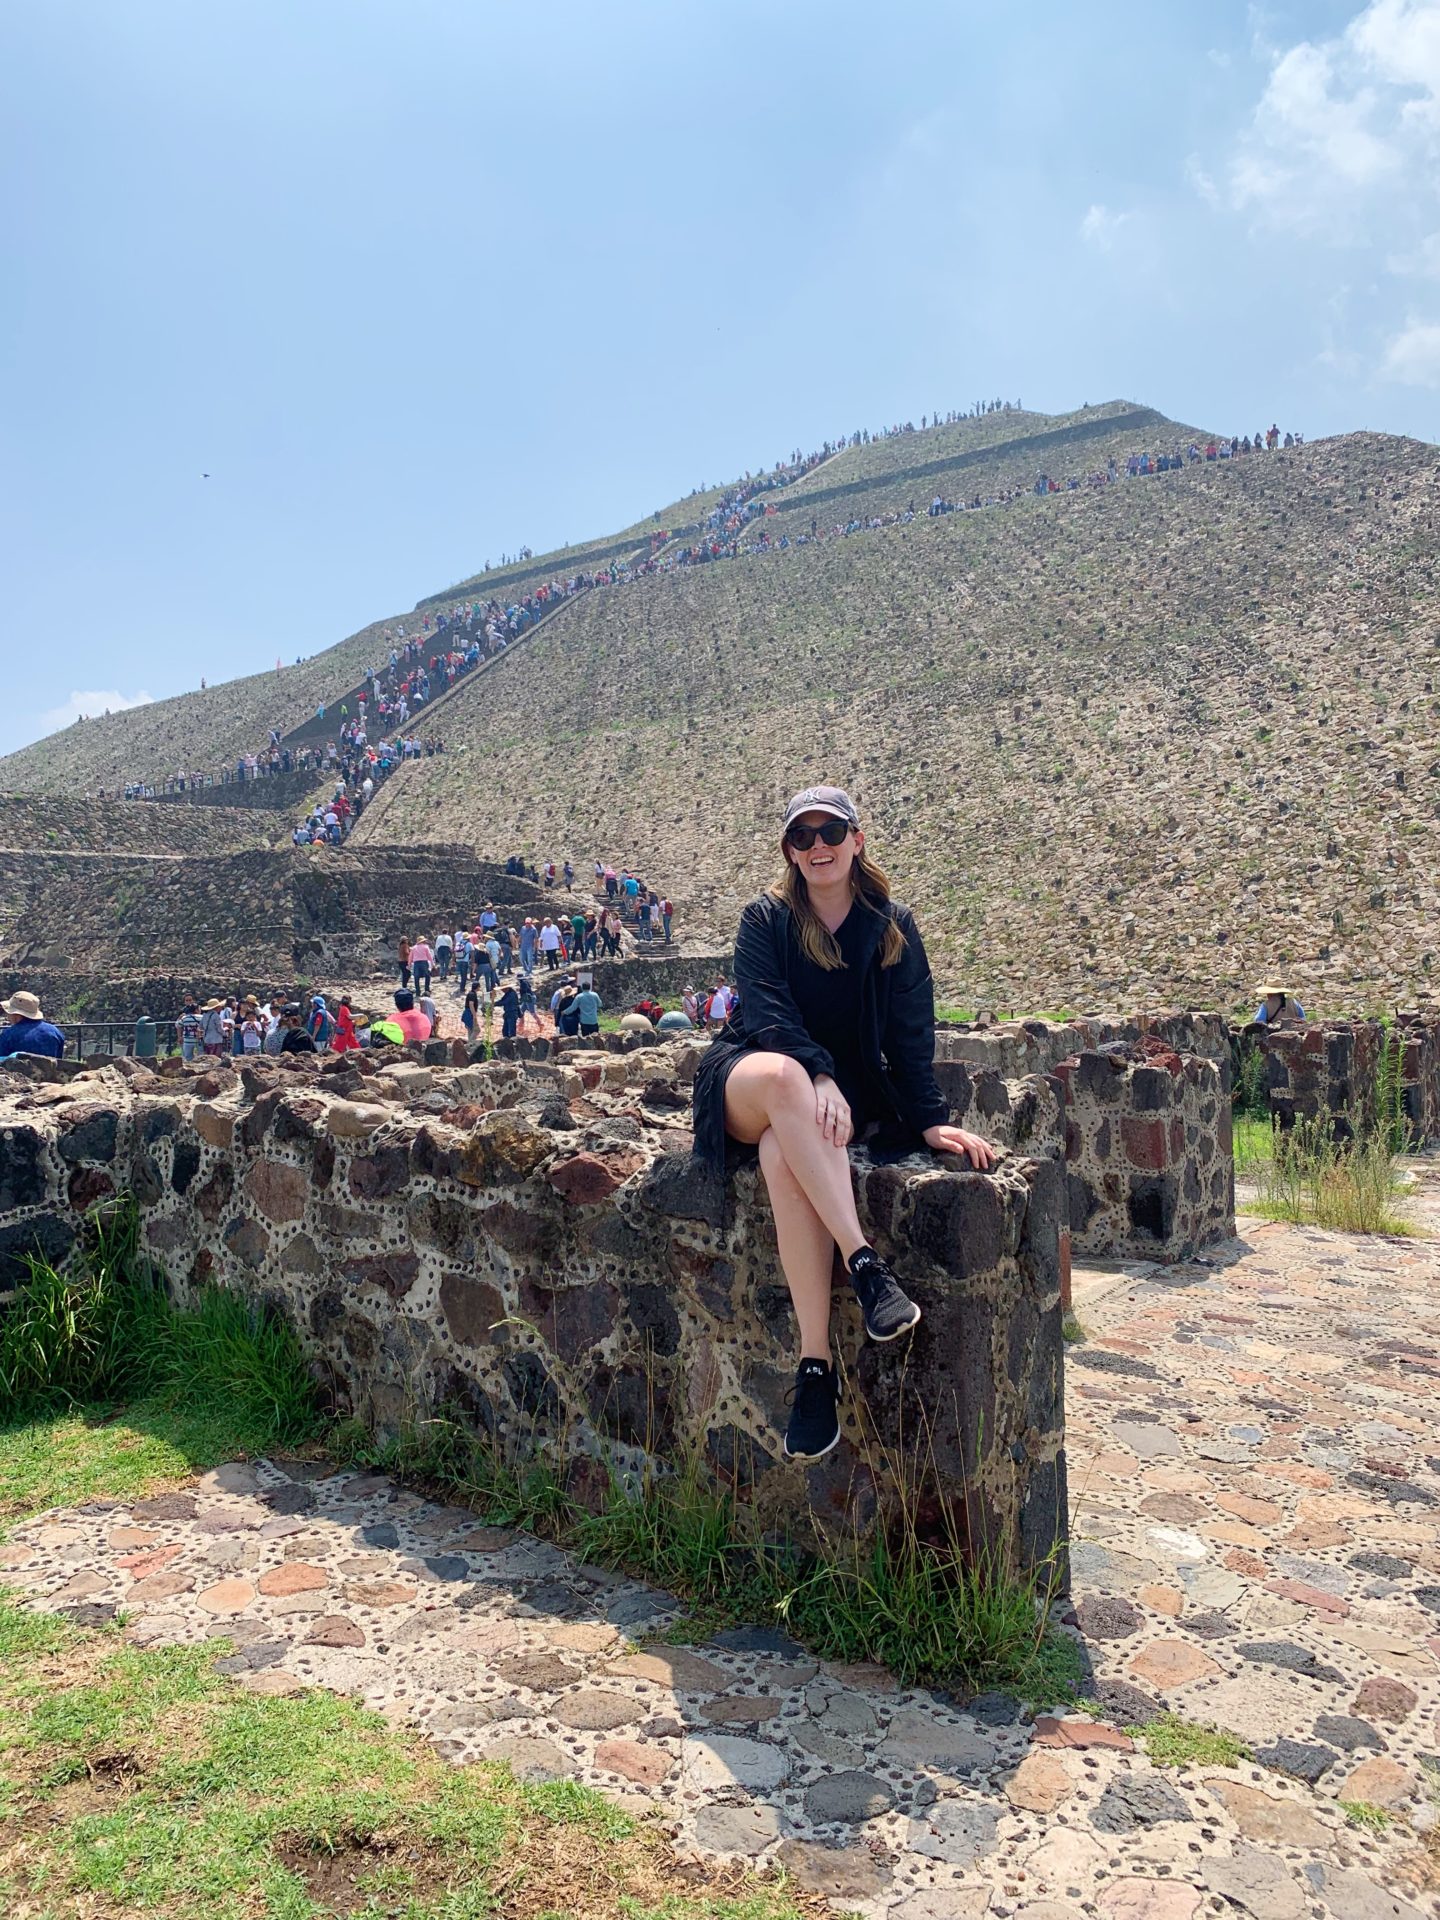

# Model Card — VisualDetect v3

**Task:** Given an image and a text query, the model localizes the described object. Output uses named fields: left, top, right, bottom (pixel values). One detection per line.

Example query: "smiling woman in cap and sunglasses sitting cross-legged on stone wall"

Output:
left=695, top=785, right=995, bottom=1461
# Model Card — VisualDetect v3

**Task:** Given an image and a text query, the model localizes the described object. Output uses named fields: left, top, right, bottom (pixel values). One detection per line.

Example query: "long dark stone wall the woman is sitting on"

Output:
left=0, top=1039, right=1066, bottom=1563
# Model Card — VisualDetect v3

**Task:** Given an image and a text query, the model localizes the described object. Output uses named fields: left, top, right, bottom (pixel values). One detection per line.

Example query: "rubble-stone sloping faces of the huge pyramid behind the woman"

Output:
left=0, top=403, right=1440, bottom=1012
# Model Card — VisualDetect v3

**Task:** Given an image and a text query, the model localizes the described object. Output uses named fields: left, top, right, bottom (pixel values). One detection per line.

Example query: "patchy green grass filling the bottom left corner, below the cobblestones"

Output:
left=0, top=1597, right=814, bottom=1920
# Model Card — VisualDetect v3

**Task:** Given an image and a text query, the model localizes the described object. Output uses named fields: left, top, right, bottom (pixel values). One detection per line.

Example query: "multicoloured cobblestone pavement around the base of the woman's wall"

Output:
left=0, top=1169, right=1440, bottom=1920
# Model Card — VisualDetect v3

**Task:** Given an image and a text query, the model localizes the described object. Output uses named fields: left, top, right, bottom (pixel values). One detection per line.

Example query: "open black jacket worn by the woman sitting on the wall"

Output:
left=695, top=893, right=950, bottom=1167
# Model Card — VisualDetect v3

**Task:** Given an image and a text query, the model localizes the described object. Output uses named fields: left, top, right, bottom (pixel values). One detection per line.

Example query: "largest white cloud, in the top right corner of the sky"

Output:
left=1221, top=0, right=1440, bottom=242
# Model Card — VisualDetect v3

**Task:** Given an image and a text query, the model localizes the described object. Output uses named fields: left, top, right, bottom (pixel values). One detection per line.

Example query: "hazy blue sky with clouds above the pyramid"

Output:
left=0, top=0, right=1440, bottom=751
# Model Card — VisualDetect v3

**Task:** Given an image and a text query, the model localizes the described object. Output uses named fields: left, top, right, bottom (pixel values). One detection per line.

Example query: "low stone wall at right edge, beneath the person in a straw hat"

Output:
left=1236, top=1012, right=1440, bottom=1146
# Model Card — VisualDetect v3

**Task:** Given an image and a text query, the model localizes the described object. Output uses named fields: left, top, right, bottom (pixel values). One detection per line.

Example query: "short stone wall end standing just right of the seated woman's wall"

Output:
left=1054, top=1037, right=1235, bottom=1261
